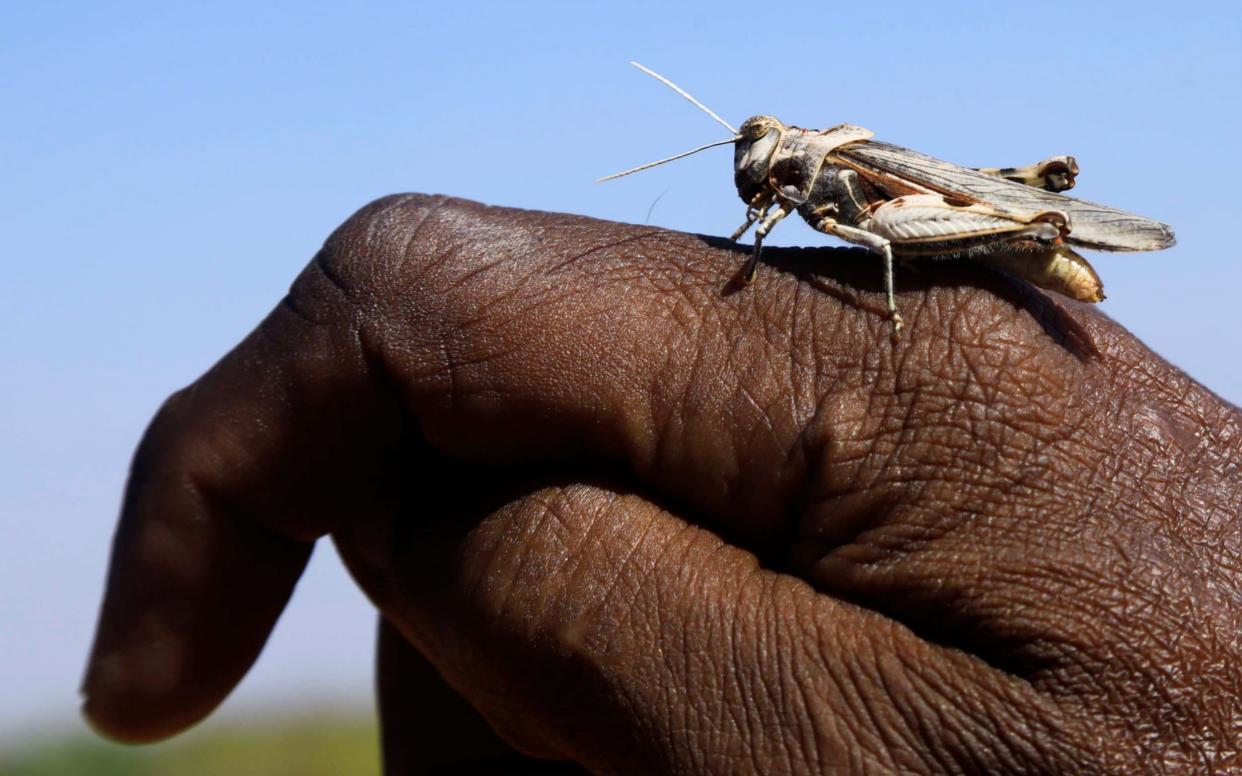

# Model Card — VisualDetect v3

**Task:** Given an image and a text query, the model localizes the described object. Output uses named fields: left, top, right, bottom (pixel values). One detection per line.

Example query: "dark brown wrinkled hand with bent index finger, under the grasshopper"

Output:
left=84, top=196, right=1242, bottom=774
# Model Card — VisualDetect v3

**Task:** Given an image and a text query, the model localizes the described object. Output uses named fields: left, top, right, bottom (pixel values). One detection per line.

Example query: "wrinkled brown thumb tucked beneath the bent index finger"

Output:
left=337, top=485, right=1099, bottom=772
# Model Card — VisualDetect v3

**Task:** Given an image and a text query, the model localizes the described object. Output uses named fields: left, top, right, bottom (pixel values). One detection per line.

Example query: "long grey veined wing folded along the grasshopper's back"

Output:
left=833, top=140, right=1175, bottom=251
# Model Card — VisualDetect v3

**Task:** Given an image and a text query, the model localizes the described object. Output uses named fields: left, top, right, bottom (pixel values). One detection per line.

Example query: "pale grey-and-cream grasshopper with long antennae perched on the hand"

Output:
left=599, top=62, right=1175, bottom=335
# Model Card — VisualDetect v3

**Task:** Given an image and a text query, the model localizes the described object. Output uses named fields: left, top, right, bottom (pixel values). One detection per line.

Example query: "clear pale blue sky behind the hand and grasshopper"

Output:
left=0, top=0, right=1242, bottom=739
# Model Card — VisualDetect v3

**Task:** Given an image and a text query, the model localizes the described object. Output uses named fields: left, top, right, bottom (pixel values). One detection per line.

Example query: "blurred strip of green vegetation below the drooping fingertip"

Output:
left=0, top=714, right=380, bottom=776
